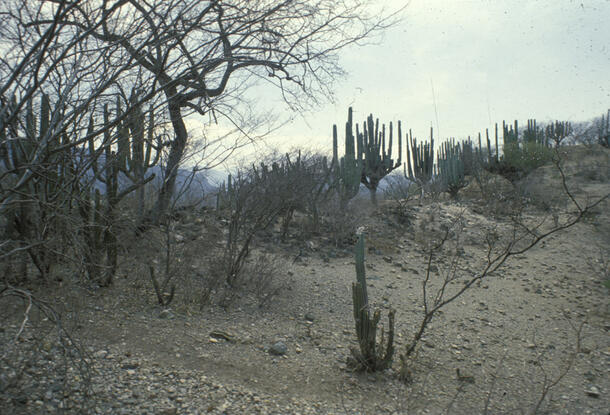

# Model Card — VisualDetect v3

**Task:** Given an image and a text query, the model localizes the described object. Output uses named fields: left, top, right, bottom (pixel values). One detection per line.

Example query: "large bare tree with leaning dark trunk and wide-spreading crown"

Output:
left=52, top=0, right=391, bottom=221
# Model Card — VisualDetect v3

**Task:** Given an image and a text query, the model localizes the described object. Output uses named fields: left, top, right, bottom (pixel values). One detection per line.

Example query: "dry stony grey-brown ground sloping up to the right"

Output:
left=0, top=148, right=610, bottom=415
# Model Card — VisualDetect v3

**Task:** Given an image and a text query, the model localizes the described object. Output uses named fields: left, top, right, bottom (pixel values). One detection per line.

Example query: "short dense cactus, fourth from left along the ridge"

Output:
left=437, top=140, right=472, bottom=199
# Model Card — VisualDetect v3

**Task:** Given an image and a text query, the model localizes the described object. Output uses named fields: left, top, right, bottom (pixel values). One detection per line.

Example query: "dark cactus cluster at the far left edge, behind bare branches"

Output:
left=0, top=94, right=73, bottom=278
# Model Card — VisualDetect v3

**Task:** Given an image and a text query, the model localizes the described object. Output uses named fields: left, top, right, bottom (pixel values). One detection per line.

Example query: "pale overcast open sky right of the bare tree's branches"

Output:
left=249, top=0, right=610, bottom=158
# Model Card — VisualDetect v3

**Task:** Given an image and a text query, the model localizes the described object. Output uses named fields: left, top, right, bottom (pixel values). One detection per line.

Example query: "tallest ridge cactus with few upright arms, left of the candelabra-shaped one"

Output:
left=330, top=107, right=364, bottom=210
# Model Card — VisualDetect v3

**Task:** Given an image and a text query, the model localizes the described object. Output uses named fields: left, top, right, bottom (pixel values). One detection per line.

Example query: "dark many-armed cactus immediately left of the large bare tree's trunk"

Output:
left=79, top=93, right=160, bottom=286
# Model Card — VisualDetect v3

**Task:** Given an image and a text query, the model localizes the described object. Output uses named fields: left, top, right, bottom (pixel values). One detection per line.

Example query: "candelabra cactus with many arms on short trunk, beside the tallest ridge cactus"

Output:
left=356, top=114, right=402, bottom=205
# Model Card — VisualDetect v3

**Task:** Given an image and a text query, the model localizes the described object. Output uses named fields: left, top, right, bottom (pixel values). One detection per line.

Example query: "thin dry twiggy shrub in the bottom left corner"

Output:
left=0, top=287, right=92, bottom=414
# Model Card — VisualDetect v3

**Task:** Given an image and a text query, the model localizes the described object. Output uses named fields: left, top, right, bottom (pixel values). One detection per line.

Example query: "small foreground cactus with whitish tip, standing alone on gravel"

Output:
left=348, top=233, right=395, bottom=372
